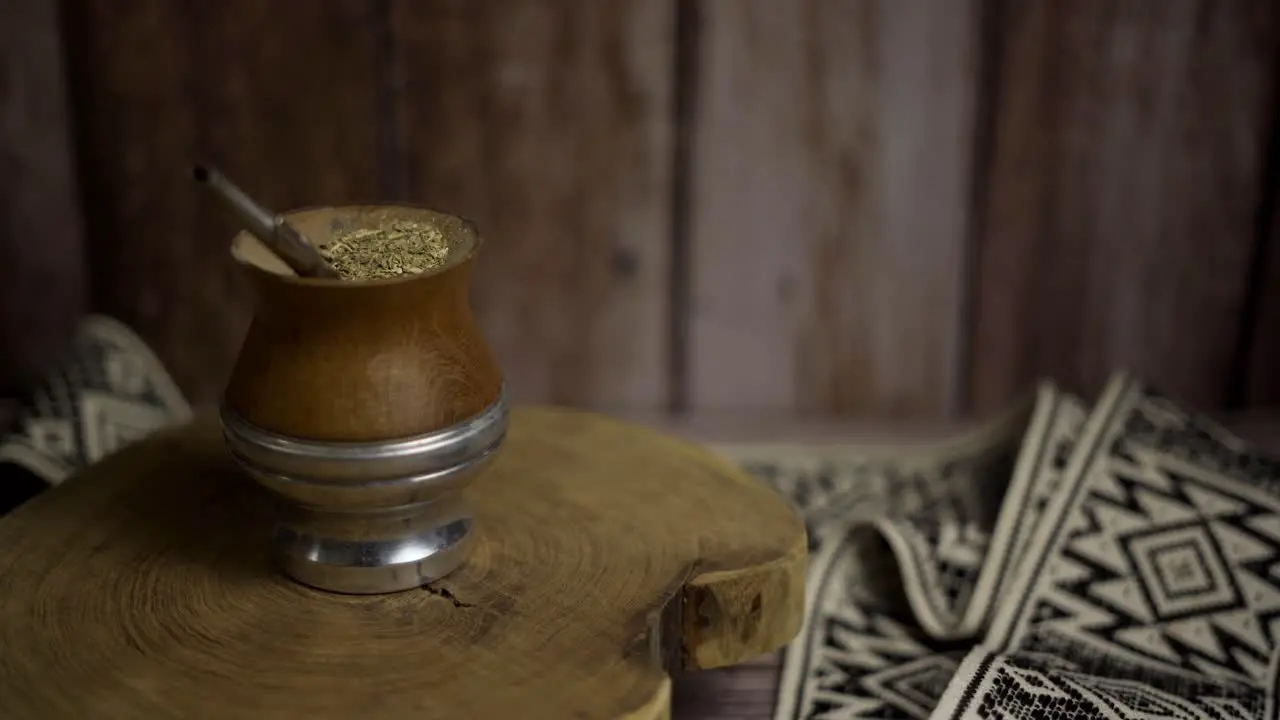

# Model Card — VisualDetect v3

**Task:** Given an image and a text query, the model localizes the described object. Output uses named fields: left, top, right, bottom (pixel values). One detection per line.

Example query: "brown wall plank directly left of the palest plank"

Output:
left=390, top=0, right=673, bottom=407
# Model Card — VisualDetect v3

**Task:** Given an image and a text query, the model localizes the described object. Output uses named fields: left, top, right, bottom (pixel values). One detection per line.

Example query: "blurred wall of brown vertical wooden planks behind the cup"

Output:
left=0, top=0, right=1280, bottom=418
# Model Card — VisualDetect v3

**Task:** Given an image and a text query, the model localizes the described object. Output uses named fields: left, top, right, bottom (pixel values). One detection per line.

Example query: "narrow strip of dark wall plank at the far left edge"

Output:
left=0, top=0, right=87, bottom=397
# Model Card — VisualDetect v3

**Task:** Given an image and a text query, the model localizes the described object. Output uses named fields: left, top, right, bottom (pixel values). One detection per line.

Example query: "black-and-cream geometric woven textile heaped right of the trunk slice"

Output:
left=723, top=375, right=1280, bottom=720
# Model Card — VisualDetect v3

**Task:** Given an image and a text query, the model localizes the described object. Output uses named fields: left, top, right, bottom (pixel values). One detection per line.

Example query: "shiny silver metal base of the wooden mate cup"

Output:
left=221, top=393, right=507, bottom=594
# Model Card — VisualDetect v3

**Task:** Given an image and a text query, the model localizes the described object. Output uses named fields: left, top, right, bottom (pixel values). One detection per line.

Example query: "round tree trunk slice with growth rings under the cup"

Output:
left=0, top=409, right=806, bottom=720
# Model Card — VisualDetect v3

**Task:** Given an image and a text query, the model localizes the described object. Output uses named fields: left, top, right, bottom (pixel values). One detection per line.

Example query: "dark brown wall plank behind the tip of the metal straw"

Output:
left=67, top=0, right=384, bottom=401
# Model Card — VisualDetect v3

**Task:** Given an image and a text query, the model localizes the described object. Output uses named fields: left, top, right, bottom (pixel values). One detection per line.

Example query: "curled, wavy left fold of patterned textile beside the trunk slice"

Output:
left=717, top=383, right=1083, bottom=719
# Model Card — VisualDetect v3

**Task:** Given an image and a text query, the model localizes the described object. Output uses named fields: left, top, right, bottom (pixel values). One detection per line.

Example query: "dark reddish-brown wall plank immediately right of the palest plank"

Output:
left=970, top=0, right=1276, bottom=413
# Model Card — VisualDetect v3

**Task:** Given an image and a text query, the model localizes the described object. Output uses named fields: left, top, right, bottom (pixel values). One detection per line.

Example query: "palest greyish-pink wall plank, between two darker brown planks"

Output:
left=687, top=0, right=977, bottom=416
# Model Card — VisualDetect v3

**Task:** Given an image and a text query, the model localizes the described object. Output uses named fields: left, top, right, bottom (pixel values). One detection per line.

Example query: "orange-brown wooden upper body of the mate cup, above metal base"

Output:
left=227, top=205, right=503, bottom=442
